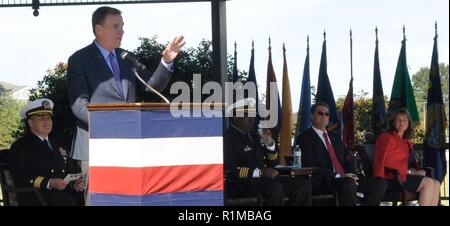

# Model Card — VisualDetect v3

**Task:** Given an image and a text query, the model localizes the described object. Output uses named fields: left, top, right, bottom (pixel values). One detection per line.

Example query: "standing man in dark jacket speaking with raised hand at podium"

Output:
left=67, top=6, right=184, bottom=204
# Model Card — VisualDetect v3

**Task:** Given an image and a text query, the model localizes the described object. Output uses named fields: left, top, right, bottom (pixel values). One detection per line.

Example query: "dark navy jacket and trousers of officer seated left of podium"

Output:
left=9, top=132, right=83, bottom=205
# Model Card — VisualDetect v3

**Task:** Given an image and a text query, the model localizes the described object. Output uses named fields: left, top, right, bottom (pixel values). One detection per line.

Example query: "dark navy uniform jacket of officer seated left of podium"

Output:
left=9, top=132, right=81, bottom=204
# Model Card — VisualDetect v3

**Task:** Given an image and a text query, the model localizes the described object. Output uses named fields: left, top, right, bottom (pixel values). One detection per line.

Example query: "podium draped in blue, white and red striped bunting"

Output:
left=88, top=103, right=224, bottom=206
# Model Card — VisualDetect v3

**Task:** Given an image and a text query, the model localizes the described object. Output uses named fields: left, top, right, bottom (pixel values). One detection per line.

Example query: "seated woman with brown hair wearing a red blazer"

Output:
left=373, top=108, right=441, bottom=206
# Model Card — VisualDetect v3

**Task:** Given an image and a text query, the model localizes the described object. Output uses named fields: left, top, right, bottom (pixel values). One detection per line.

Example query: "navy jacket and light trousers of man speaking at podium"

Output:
left=67, top=42, right=171, bottom=160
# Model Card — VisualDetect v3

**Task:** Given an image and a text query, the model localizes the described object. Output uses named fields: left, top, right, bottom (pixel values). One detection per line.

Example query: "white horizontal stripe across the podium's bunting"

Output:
left=89, top=137, right=223, bottom=167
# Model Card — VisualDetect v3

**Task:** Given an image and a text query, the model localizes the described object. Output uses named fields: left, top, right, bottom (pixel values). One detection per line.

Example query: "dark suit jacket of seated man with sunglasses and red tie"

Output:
left=297, top=128, right=354, bottom=177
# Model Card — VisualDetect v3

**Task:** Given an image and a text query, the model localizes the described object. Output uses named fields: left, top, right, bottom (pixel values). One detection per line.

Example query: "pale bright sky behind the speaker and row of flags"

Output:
left=0, top=0, right=449, bottom=107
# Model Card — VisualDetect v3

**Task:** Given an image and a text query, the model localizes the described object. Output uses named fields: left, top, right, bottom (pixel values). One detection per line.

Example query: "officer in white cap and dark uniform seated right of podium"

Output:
left=223, top=98, right=311, bottom=206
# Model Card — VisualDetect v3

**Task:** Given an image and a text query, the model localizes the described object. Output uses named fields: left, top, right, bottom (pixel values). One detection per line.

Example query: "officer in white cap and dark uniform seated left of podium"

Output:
left=9, top=98, right=84, bottom=206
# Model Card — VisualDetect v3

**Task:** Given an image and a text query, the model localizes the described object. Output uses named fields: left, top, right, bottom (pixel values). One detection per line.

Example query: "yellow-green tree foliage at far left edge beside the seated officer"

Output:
left=0, top=92, right=23, bottom=150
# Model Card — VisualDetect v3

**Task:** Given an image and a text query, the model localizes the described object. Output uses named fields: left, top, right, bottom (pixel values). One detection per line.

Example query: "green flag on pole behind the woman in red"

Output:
left=388, top=30, right=419, bottom=126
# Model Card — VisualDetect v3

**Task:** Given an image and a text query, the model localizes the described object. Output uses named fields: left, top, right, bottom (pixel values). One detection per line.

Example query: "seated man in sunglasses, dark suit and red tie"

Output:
left=297, top=102, right=387, bottom=206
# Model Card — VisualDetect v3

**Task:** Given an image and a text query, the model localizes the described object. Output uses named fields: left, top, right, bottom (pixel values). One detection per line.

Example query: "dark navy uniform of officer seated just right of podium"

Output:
left=224, top=125, right=311, bottom=205
